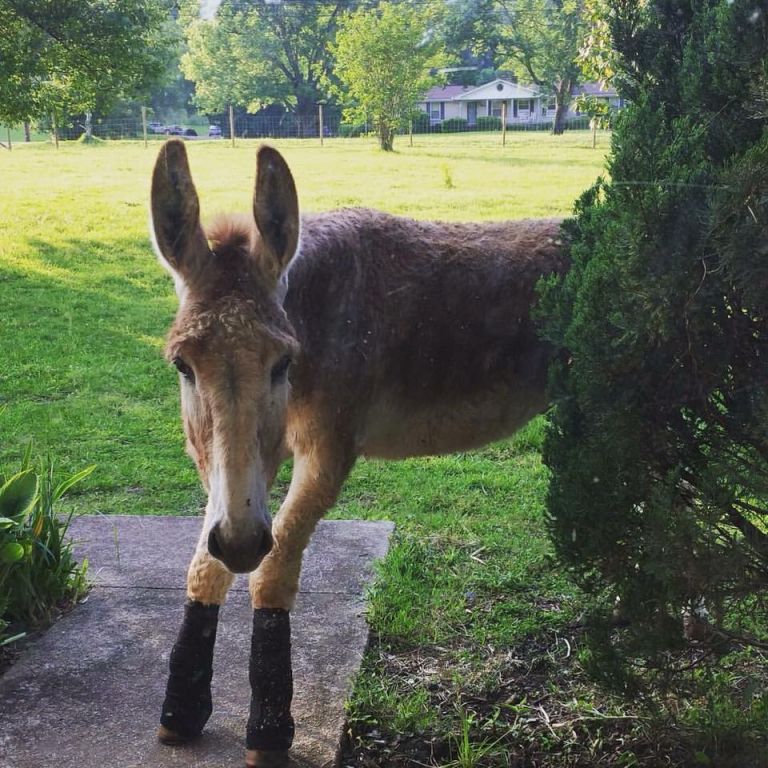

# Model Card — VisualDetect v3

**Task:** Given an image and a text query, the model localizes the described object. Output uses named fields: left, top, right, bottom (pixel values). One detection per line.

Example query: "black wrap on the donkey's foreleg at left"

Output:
left=160, top=600, right=219, bottom=739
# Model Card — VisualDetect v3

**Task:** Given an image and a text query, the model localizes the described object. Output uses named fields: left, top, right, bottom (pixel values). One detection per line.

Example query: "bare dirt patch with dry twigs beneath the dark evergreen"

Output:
left=341, top=630, right=768, bottom=768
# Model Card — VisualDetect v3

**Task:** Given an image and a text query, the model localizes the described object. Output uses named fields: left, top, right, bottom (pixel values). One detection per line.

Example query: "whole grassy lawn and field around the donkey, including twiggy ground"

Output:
left=0, top=133, right=768, bottom=768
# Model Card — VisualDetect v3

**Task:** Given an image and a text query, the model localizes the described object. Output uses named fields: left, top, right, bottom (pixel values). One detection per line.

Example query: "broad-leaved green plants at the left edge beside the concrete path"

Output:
left=0, top=450, right=93, bottom=646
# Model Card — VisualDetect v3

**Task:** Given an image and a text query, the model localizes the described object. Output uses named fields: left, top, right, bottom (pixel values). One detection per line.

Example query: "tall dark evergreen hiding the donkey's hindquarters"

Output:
left=540, top=0, right=768, bottom=684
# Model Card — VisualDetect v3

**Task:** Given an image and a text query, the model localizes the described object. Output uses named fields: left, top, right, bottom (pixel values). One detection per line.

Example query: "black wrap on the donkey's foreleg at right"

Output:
left=246, top=608, right=294, bottom=751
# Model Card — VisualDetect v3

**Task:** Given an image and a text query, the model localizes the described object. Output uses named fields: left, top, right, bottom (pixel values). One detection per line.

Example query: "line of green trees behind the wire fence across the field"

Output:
left=0, top=0, right=608, bottom=149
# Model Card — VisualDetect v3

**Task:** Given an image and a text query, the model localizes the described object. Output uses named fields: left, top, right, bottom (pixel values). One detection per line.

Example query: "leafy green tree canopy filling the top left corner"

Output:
left=0, top=0, right=168, bottom=129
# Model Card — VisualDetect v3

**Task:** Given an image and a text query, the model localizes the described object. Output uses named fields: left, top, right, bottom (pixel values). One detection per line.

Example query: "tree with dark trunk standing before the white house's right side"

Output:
left=497, top=0, right=586, bottom=134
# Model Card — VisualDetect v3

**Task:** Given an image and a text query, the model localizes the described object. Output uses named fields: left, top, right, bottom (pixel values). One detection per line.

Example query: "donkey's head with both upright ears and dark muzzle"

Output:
left=152, top=140, right=299, bottom=572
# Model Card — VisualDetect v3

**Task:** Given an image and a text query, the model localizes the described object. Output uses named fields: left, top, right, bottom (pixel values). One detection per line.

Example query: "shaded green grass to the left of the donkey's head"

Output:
left=0, top=238, right=199, bottom=513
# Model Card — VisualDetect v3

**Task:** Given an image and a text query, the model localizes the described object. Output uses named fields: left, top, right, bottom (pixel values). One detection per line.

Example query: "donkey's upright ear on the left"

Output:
left=152, top=139, right=208, bottom=279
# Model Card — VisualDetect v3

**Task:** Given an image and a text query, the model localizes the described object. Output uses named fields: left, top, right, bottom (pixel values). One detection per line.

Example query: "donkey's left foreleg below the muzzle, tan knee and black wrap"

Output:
left=158, top=537, right=234, bottom=744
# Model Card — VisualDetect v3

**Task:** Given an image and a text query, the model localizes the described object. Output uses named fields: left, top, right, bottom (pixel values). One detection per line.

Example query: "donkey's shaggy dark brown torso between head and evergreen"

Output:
left=285, top=210, right=563, bottom=457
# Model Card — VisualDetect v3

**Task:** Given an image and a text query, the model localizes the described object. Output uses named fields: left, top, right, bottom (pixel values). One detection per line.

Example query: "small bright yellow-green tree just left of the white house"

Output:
left=331, top=3, right=445, bottom=152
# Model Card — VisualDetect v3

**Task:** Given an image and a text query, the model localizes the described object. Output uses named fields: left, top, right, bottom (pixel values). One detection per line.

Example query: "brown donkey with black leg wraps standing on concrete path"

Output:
left=151, top=140, right=567, bottom=768
